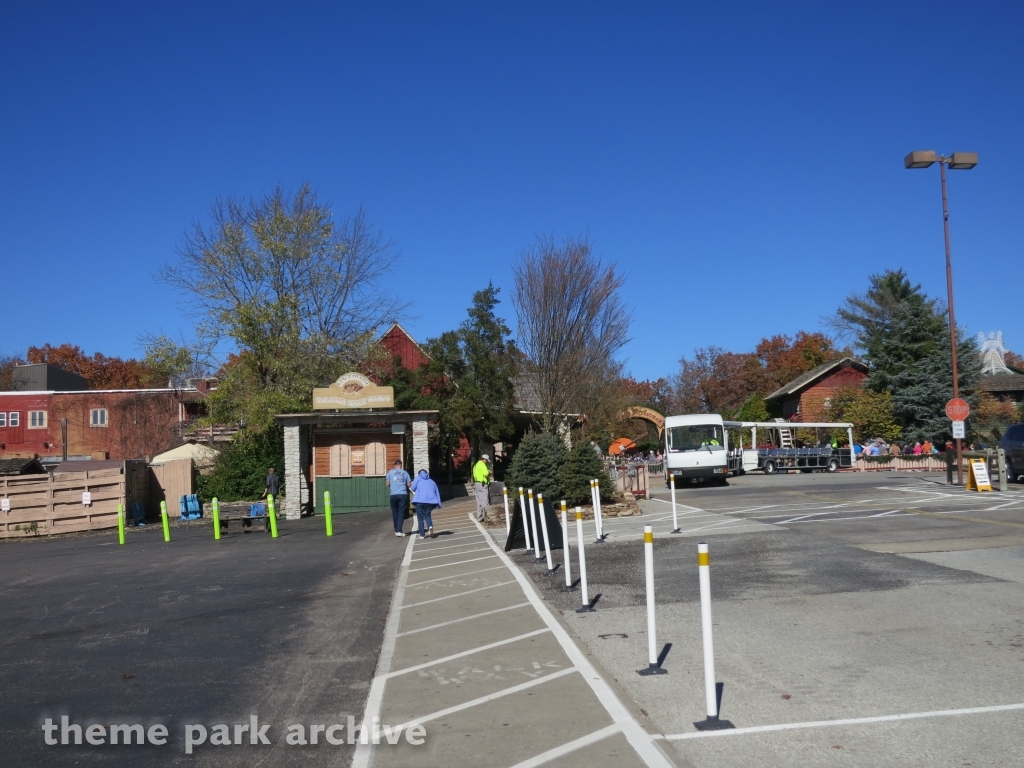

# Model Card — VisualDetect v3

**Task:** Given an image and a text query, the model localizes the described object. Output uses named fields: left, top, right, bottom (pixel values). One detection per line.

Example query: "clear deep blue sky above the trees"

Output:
left=0, top=2, right=1024, bottom=378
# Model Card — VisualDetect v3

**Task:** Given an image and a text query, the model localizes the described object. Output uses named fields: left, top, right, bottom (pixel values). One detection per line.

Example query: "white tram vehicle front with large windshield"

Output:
left=665, top=414, right=729, bottom=485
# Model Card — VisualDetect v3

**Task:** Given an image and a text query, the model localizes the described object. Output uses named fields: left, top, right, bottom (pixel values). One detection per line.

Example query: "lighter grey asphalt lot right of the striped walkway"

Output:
left=509, top=472, right=1024, bottom=768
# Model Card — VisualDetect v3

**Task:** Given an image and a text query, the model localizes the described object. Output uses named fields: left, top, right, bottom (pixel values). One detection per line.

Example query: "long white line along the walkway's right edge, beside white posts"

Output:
left=468, top=523, right=673, bottom=768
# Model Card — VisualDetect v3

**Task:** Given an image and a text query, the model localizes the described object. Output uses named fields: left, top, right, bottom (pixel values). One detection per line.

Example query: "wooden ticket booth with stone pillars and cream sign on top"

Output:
left=274, top=374, right=437, bottom=518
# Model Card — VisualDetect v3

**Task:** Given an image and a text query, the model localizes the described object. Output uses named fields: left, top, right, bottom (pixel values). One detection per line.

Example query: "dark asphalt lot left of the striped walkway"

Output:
left=0, top=513, right=408, bottom=766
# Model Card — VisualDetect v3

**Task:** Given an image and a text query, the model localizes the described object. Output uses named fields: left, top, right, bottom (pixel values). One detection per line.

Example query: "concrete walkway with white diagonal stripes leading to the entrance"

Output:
left=352, top=503, right=675, bottom=768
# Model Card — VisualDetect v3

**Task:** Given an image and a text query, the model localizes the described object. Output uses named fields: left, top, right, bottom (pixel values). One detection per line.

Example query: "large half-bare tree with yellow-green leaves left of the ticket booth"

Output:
left=150, top=184, right=404, bottom=430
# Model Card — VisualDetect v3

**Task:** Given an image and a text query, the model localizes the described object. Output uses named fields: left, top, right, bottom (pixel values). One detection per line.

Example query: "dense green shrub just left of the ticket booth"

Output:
left=197, top=427, right=286, bottom=502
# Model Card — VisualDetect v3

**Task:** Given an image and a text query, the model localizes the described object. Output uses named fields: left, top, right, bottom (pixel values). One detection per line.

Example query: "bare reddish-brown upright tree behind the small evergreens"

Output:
left=512, top=237, right=631, bottom=432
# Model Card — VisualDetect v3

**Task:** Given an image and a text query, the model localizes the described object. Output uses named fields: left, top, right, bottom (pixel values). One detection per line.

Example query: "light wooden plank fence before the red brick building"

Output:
left=0, top=461, right=150, bottom=539
